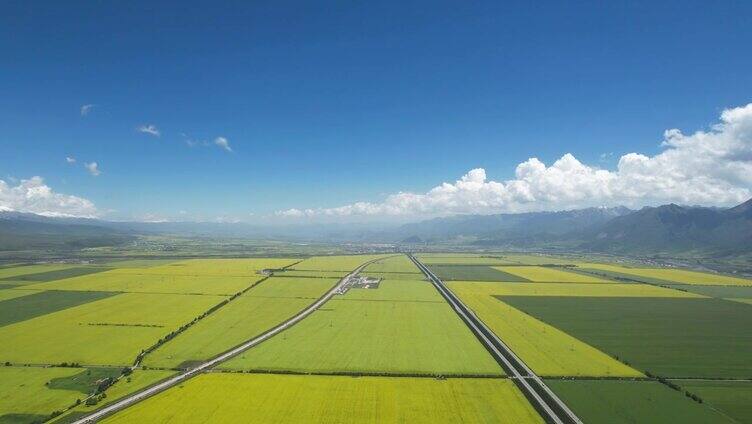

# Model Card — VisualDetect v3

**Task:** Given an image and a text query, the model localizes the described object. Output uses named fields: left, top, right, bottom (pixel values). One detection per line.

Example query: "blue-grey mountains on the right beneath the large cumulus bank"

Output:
left=393, top=199, right=752, bottom=256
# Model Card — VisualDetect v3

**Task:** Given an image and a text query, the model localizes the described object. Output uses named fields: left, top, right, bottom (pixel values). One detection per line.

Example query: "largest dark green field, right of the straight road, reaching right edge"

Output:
left=503, top=296, right=752, bottom=378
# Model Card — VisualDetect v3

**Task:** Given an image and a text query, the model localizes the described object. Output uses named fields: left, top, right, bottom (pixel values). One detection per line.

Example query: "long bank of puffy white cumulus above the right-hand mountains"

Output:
left=276, top=104, right=752, bottom=218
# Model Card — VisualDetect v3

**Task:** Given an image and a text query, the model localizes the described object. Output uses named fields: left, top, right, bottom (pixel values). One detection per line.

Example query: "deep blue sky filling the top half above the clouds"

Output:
left=0, top=2, right=752, bottom=220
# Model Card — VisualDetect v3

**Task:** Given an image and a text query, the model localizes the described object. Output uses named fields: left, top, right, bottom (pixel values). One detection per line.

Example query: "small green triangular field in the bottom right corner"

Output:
left=674, top=380, right=752, bottom=423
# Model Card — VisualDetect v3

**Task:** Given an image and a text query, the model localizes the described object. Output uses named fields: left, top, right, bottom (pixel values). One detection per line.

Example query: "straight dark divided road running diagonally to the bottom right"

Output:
left=408, top=254, right=582, bottom=424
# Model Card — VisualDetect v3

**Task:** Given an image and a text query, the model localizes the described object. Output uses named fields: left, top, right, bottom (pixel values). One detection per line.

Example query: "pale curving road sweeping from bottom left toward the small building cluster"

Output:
left=74, top=258, right=381, bottom=424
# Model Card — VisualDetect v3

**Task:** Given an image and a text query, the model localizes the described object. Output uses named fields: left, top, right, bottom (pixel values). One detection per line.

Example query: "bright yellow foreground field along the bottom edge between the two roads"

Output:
left=104, top=373, right=543, bottom=424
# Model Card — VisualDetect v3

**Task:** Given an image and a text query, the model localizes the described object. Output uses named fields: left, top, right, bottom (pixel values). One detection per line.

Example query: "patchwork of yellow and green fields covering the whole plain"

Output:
left=0, top=253, right=752, bottom=423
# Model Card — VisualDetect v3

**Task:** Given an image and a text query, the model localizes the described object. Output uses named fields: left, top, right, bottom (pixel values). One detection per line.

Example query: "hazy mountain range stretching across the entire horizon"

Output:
left=0, top=199, right=752, bottom=256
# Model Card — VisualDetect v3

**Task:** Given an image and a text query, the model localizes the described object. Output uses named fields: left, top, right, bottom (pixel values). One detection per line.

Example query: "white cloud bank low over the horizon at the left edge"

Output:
left=0, top=177, right=99, bottom=218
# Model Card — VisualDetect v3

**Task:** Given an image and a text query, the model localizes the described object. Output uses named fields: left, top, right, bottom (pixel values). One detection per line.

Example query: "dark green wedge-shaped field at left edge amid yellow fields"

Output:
left=0, top=290, right=117, bottom=327
